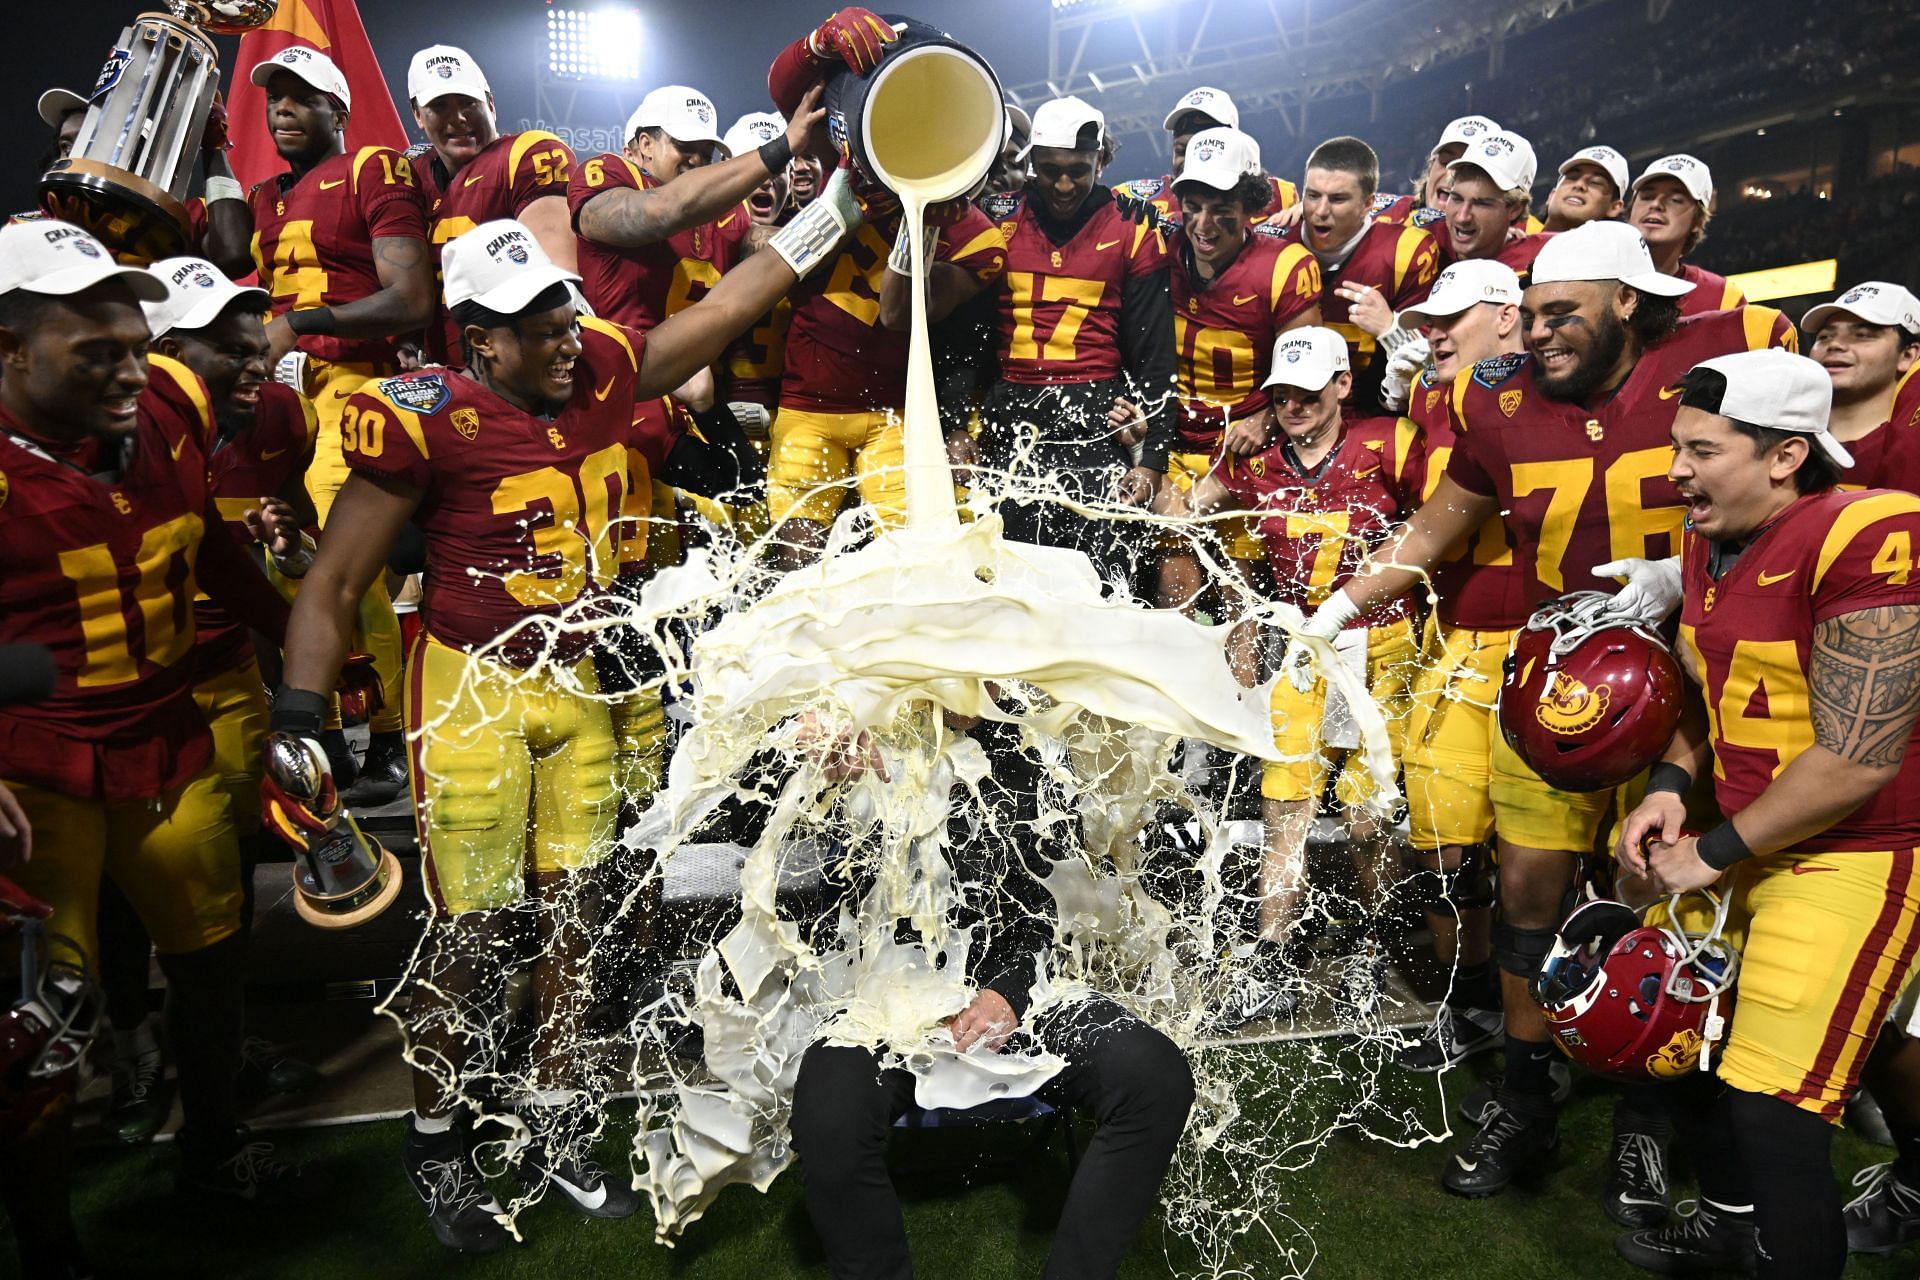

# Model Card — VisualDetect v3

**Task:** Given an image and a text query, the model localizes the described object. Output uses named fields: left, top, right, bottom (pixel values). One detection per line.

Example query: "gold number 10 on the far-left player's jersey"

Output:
left=60, top=512, right=202, bottom=689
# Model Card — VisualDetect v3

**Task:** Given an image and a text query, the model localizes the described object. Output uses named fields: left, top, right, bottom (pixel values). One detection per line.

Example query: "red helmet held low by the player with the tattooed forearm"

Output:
left=1532, top=892, right=1740, bottom=1080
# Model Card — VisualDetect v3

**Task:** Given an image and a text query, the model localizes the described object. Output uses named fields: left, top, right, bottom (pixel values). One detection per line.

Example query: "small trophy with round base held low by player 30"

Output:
left=259, top=731, right=401, bottom=929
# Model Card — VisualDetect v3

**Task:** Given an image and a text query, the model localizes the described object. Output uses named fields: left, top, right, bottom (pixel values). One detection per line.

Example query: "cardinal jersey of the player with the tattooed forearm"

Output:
left=1680, top=489, right=1920, bottom=852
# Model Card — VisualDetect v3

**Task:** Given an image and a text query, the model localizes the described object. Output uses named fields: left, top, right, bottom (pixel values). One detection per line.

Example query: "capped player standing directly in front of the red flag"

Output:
left=239, top=44, right=436, bottom=802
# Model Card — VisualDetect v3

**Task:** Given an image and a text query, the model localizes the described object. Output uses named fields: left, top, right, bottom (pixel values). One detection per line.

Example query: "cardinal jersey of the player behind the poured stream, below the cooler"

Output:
left=780, top=205, right=1006, bottom=413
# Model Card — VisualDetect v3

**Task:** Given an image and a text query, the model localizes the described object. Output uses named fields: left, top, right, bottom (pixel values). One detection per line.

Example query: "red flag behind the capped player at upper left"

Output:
left=227, top=0, right=407, bottom=188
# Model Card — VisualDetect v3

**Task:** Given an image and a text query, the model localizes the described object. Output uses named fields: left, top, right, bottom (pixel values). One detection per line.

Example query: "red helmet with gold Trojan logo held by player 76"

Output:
left=1500, top=591, right=1680, bottom=791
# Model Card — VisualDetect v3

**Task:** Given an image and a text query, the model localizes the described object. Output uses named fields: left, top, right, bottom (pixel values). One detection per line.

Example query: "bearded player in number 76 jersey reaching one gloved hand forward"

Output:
left=1283, top=223, right=1795, bottom=1196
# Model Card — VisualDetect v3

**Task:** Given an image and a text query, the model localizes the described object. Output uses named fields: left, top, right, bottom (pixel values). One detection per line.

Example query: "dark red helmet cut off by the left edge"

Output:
left=0, top=875, right=100, bottom=1142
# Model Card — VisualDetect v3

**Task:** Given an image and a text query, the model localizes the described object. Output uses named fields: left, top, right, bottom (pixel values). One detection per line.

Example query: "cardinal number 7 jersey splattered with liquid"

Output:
left=1213, top=415, right=1421, bottom=628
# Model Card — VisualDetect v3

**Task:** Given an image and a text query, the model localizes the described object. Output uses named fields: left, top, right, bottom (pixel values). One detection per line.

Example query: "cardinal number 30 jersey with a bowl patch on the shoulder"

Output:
left=340, top=319, right=645, bottom=664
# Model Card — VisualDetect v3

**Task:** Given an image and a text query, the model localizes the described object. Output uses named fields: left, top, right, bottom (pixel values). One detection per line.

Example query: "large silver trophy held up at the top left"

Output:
left=40, top=0, right=278, bottom=263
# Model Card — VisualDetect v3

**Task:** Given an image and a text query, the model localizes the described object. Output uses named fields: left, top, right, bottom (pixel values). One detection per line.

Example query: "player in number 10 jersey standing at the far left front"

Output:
left=0, top=219, right=300, bottom=1266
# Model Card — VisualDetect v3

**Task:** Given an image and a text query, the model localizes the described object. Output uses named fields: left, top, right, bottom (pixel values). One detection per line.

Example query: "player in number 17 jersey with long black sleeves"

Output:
left=979, top=98, right=1175, bottom=576
